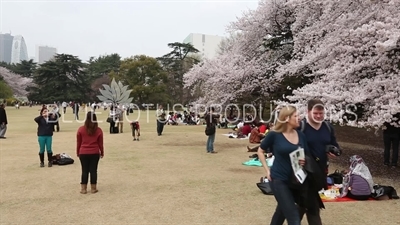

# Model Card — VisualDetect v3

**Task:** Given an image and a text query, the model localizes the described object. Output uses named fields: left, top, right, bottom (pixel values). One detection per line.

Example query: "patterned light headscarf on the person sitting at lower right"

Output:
left=340, top=155, right=374, bottom=197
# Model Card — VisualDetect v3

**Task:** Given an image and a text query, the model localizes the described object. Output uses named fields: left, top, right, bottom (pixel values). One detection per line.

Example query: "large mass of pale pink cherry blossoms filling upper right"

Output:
left=185, top=0, right=400, bottom=127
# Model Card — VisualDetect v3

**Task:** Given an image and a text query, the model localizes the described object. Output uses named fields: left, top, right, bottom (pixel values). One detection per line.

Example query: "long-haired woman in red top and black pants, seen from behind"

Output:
left=76, top=112, right=104, bottom=194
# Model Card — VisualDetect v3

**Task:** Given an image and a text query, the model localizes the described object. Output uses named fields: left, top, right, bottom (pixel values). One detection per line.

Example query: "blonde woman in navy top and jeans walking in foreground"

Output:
left=257, top=106, right=308, bottom=225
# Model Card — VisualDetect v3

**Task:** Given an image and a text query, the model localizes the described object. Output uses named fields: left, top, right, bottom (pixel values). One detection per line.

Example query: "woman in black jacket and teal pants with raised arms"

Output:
left=34, top=108, right=56, bottom=167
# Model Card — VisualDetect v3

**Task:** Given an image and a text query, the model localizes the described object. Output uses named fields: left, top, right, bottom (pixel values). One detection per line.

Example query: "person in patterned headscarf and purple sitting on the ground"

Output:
left=340, top=155, right=374, bottom=200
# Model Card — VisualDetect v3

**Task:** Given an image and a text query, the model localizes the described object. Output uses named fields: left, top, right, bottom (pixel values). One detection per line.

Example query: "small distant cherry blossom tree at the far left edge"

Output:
left=0, top=67, right=32, bottom=97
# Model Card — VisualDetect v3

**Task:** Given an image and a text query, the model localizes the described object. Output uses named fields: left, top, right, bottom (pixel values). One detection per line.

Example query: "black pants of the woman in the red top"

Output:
left=79, top=154, right=100, bottom=184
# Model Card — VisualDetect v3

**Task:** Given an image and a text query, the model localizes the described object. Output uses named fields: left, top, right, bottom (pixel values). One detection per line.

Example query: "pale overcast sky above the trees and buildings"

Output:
left=0, top=0, right=258, bottom=61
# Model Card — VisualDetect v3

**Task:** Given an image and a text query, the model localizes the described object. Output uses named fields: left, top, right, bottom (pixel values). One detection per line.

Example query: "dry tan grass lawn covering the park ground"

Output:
left=0, top=106, right=400, bottom=225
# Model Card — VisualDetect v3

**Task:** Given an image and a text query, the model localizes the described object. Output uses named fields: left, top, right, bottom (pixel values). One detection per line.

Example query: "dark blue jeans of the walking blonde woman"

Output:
left=270, top=179, right=300, bottom=225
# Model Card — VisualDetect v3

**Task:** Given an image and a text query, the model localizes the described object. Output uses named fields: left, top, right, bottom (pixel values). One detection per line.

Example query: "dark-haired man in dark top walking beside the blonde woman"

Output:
left=299, top=99, right=340, bottom=225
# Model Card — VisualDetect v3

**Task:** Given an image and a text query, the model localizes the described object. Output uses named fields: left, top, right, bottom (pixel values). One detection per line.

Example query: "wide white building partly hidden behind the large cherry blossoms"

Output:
left=183, top=33, right=223, bottom=59
